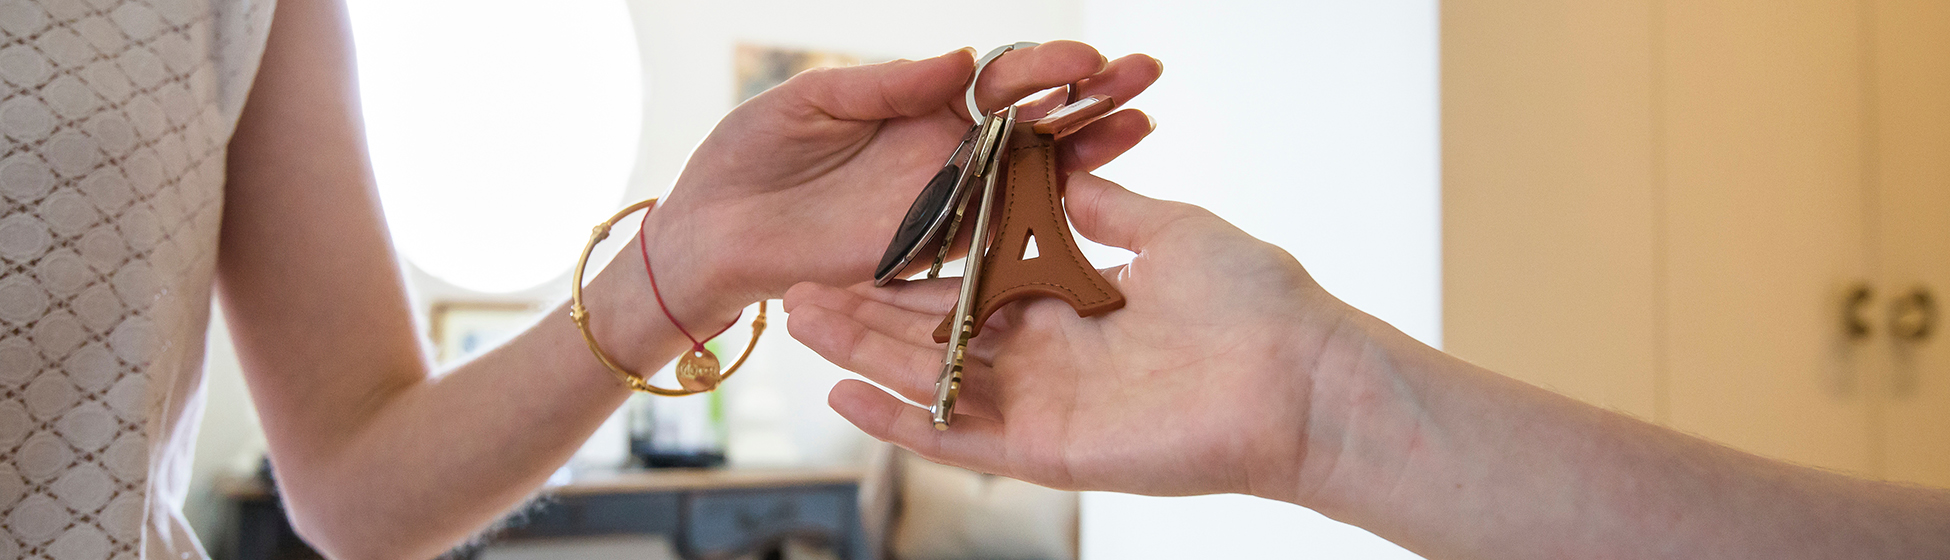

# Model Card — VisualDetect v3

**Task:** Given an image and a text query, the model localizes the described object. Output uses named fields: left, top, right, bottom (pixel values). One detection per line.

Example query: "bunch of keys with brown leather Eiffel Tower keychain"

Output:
left=874, top=43, right=1123, bottom=429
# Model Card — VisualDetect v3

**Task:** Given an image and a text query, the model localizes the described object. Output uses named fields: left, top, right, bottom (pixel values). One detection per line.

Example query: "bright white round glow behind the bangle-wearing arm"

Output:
left=349, top=0, right=642, bottom=293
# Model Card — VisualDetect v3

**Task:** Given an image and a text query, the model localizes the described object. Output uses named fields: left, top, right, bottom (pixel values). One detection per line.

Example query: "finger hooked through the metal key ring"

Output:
left=954, top=41, right=1121, bottom=113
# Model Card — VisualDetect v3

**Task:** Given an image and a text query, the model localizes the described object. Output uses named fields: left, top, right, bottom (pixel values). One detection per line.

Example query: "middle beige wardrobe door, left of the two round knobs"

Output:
left=1656, top=0, right=1874, bottom=472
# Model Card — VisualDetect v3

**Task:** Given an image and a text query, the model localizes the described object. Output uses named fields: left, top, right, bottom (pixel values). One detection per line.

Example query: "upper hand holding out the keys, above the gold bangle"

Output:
left=643, top=41, right=1162, bottom=322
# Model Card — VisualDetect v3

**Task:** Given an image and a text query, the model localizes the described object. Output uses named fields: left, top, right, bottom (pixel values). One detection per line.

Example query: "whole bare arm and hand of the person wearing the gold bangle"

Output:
left=218, top=0, right=1158, bottom=558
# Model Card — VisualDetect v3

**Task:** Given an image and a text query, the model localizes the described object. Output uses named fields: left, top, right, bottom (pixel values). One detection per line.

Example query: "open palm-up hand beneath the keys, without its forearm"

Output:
left=786, top=174, right=1361, bottom=500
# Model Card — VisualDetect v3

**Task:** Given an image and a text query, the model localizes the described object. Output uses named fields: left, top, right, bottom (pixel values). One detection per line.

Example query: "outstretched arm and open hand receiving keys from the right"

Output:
left=786, top=174, right=1950, bottom=558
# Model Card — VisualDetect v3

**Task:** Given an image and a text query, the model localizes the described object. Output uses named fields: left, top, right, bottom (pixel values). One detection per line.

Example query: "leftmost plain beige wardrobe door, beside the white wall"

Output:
left=1441, top=0, right=1658, bottom=420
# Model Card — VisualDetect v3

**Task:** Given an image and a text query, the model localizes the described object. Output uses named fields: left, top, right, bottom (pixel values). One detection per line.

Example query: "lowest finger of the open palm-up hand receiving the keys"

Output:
left=827, top=379, right=1008, bottom=474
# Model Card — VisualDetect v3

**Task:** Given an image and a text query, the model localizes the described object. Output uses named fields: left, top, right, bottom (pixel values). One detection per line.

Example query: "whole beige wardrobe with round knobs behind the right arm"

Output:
left=1441, top=0, right=1950, bottom=486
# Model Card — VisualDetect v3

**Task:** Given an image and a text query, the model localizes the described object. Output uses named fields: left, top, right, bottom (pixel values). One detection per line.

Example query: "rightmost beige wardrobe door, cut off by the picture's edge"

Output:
left=1870, top=0, right=1950, bottom=486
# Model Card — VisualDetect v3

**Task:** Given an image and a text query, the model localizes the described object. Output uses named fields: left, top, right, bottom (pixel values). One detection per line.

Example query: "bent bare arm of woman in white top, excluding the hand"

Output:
left=218, top=2, right=666, bottom=558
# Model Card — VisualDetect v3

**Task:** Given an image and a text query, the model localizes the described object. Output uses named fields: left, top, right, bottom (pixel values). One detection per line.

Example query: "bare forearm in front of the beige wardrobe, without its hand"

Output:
left=1301, top=316, right=1950, bottom=558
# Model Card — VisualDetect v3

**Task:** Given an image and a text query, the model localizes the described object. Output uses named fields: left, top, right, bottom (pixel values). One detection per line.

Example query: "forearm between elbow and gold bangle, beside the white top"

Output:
left=273, top=304, right=628, bottom=558
